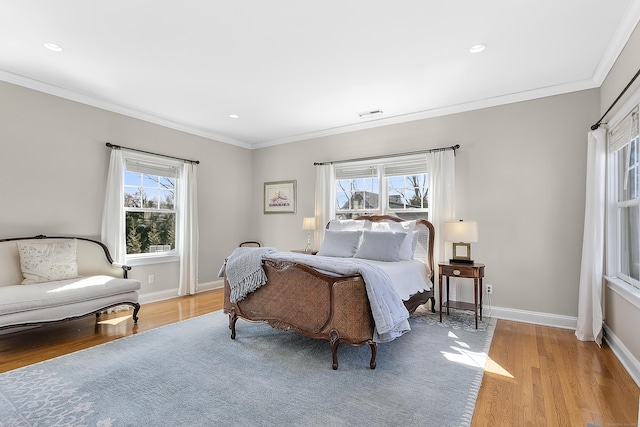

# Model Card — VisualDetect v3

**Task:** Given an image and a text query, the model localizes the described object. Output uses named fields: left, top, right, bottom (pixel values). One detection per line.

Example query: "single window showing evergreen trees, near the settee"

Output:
left=124, top=158, right=179, bottom=257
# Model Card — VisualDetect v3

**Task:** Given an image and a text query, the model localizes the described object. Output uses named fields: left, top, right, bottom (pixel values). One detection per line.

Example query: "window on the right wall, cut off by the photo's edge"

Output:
left=609, top=107, right=640, bottom=287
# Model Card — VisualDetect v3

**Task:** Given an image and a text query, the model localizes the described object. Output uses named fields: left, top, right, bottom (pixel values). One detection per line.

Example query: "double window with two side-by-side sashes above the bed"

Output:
left=335, top=156, right=429, bottom=219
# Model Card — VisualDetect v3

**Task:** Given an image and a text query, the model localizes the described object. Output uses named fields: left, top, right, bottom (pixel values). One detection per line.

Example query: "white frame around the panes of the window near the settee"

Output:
left=121, top=151, right=182, bottom=266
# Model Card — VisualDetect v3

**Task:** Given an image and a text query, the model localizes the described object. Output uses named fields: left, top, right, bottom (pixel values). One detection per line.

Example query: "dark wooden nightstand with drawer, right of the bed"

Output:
left=438, top=262, right=484, bottom=329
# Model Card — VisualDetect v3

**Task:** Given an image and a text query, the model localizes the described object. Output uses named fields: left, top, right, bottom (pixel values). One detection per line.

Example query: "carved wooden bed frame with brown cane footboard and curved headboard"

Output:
left=224, top=215, right=435, bottom=369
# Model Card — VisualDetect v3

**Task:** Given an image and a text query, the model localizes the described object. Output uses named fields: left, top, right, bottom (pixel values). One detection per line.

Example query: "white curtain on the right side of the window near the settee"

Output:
left=178, top=162, right=198, bottom=296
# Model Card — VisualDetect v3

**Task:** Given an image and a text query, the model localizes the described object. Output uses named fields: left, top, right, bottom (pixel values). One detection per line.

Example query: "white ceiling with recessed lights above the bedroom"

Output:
left=0, top=0, right=640, bottom=148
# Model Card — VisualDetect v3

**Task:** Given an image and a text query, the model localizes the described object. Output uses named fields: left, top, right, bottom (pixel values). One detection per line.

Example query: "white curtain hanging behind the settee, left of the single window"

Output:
left=101, top=148, right=127, bottom=264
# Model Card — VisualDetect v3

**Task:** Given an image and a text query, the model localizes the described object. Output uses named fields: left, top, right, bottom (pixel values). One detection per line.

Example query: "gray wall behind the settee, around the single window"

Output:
left=0, top=82, right=251, bottom=300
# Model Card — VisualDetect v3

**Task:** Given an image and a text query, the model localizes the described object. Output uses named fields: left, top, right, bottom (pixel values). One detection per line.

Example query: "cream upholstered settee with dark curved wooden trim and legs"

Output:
left=0, top=236, right=140, bottom=329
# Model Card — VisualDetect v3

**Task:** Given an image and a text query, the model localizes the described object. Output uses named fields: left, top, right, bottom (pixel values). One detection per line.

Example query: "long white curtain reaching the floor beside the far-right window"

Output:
left=576, top=127, right=607, bottom=345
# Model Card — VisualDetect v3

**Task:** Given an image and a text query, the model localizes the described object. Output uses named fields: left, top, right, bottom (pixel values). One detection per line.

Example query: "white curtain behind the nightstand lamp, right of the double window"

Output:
left=426, top=150, right=456, bottom=264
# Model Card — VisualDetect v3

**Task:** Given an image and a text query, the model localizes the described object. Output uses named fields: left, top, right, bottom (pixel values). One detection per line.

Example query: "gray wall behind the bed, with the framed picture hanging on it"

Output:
left=252, top=89, right=600, bottom=316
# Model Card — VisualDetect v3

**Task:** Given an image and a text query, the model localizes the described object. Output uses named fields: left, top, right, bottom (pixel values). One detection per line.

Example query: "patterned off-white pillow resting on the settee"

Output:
left=16, top=239, right=78, bottom=285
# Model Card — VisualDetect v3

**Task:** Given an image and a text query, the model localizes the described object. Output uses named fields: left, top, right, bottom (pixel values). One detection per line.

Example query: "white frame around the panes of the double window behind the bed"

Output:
left=332, top=155, right=430, bottom=218
